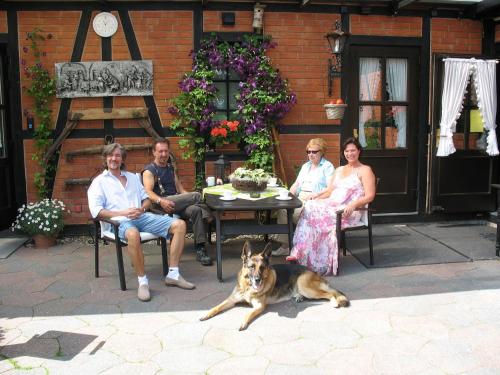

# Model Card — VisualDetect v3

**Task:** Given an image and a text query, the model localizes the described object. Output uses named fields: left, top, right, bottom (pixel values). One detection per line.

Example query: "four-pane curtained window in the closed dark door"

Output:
left=358, top=57, right=409, bottom=150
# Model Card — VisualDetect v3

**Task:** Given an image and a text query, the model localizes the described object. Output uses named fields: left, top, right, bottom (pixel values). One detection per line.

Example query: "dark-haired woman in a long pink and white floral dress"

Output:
left=287, top=138, right=375, bottom=275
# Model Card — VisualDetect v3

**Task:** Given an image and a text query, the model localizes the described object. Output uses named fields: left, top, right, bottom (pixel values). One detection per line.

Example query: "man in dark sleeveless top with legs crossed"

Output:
left=142, top=138, right=212, bottom=266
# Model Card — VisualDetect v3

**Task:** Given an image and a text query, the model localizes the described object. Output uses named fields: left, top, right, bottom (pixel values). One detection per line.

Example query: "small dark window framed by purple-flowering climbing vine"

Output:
left=214, top=69, right=240, bottom=120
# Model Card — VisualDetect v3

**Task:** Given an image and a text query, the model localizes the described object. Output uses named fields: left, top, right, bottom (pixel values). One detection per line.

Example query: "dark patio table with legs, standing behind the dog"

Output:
left=204, top=188, right=302, bottom=282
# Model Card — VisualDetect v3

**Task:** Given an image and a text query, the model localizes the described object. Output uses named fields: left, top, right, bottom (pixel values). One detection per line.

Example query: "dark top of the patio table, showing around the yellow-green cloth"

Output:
left=205, top=194, right=302, bottom=211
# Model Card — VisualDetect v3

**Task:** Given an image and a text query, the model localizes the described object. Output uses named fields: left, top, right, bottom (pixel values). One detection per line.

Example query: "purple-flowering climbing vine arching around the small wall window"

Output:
left=169, top=35, right=297, bottom=188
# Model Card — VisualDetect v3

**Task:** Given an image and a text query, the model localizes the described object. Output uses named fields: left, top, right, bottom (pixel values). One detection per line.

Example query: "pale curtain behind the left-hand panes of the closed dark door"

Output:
left=358, top=58, right=380, bottom=147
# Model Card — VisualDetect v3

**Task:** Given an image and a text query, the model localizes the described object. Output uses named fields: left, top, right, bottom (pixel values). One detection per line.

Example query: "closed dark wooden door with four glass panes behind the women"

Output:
left=342, top=46, right=419, bottom=213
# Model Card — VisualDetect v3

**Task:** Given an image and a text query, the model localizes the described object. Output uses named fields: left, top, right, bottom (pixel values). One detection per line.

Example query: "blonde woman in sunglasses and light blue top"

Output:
left=272, top=138, right=334, bottom=256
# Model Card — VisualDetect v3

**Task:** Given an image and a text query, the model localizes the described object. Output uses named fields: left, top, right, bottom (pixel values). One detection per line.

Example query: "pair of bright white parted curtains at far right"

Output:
left=437, top=58, right=498, bottom=156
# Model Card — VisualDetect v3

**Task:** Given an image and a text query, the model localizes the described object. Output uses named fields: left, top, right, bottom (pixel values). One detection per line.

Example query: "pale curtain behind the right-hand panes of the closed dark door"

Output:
left=387, top=59, right=408, bottom=147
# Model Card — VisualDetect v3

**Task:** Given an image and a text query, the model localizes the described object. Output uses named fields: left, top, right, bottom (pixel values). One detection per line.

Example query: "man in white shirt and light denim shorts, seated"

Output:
left=87, top=143, right=195, bottom=301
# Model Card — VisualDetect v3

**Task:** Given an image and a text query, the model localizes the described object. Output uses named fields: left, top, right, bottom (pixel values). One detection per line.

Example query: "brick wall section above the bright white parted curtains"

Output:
left=431, top=18, right=483, bottom=54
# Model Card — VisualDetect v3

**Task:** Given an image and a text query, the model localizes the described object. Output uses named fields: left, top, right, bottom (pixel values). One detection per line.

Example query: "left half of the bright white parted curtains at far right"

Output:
left=437, top=59, right=471, bottom=156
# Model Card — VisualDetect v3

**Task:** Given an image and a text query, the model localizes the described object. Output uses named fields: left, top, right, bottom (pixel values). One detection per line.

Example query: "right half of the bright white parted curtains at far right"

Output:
left=473, top=60, right=498, bottom=156
